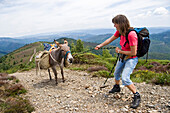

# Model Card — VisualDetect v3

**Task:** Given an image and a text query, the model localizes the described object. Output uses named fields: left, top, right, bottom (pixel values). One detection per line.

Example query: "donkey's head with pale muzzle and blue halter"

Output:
left=55, top=40, right=73, bottom=63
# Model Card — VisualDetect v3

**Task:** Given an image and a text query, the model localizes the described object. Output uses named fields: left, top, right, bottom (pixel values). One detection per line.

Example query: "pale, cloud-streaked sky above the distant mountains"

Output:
left=0, top=0, right=170, bottom=37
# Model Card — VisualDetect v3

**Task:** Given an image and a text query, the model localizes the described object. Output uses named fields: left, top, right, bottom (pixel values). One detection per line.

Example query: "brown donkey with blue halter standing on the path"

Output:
left=48, top=40, right=73, bottom=85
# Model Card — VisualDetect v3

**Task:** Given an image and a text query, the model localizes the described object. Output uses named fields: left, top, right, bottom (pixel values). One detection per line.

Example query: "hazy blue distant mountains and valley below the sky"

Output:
left=0, top=28, right=170, bottom=59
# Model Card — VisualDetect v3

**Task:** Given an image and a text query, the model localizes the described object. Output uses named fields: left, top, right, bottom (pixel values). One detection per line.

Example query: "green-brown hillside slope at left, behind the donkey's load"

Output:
left=0, top=42, right=43, bottom=73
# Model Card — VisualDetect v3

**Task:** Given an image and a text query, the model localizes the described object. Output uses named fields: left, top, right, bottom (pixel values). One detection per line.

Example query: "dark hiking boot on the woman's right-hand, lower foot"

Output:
left=130, top=92, right=141, bottom=109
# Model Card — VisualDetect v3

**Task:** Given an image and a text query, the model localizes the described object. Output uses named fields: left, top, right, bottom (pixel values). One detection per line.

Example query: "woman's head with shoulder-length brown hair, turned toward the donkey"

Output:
left=112, top=15, right=130, bottom=36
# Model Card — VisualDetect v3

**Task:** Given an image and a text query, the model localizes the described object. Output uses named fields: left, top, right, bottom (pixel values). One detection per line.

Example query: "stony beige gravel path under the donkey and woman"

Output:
left=10, top=69, right=170, bottom=113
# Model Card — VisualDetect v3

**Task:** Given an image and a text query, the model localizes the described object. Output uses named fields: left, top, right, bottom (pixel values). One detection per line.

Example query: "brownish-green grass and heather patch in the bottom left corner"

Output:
left=0, top=75, right=35, bottom=113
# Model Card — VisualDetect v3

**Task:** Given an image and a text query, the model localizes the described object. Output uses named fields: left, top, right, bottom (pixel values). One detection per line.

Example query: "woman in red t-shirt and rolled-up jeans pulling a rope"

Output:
left=95, top=15, right=140, bottom=108
